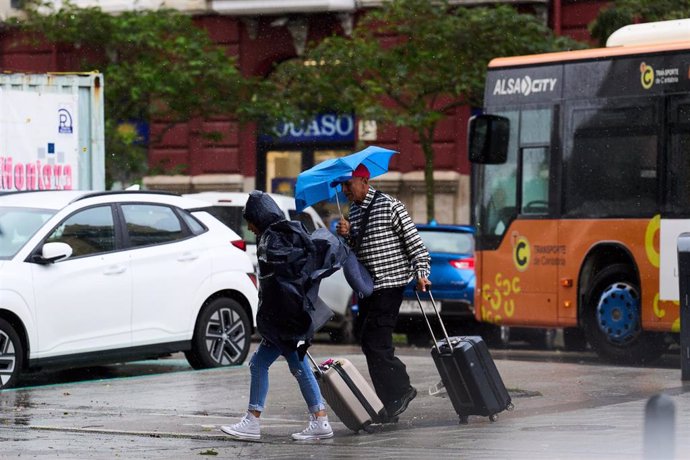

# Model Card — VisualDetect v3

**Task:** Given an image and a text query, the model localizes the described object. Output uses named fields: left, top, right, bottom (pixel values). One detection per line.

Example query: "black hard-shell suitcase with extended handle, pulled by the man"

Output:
left=415, top=291, right=514, bottom=424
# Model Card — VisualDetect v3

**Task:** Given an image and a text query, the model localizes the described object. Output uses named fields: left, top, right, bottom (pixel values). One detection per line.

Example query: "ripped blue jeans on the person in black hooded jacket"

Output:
left=248, top=340, right=326, bottom=414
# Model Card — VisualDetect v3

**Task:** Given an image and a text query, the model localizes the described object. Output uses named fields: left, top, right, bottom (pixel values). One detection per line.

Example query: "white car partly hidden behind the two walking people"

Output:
left=183, top=192, right=355, bottom=343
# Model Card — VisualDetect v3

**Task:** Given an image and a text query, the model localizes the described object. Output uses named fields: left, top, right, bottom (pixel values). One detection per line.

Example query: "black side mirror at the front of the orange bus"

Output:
left=468, top=114, right=510, bottom=165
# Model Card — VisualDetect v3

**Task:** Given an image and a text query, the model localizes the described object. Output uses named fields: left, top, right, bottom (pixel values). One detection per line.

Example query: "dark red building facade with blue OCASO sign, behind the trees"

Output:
left=0, top=0, right=606, bottom=223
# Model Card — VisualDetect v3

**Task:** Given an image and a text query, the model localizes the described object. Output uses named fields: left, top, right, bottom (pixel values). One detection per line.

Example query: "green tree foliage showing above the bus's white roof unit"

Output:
left=589, top=0, right=690, bottom=46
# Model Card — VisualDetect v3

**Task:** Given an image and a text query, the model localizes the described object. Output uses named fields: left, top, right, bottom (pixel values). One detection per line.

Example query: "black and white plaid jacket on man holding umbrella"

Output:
left=346, top=186, right=430, bottom=290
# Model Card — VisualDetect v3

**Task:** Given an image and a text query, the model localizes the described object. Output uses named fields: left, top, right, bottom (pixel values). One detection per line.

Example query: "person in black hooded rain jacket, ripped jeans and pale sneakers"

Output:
left=221, top=190, right=346, bottom=441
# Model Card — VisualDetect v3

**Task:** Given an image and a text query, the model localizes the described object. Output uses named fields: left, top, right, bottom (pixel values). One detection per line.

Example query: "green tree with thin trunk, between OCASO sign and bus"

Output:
left=255, top=0, right=582, bottom=220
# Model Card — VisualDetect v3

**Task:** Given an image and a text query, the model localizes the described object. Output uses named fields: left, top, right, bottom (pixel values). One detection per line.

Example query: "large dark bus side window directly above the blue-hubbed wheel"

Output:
left=564, top=103, right=659, bottom=217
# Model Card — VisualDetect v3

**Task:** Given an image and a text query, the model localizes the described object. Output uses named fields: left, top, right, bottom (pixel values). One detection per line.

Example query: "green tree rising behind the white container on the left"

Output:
left=14, top=3, right=249, bottom=186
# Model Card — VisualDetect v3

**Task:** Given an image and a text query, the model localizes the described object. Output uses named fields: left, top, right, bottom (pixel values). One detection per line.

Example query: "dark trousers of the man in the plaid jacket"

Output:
left=357, top=286, right=410, bottom=406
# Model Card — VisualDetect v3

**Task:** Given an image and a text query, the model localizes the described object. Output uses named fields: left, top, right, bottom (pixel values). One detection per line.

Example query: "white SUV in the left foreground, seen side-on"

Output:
left=0, top=191, right=258, bottom=388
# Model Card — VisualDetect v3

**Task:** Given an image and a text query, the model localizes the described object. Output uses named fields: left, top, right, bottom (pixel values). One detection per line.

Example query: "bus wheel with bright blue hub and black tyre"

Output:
left=584, top=264, right=666, bottom=364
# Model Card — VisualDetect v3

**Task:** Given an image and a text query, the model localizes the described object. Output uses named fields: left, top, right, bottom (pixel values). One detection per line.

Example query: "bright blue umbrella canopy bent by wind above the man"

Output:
left=295, top=145, right=398, bottom=212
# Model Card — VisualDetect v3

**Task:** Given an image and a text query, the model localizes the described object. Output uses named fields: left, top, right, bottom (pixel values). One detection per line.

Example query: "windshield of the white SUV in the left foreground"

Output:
left=0, top=206, right=55, bottom=259
